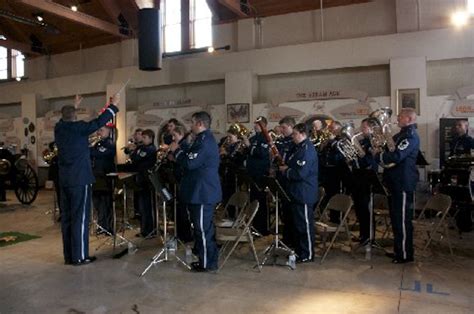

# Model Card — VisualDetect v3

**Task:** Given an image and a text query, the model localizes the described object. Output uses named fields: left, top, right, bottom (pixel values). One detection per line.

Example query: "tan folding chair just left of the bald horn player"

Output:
left=315, top=194, right=353, bottom=264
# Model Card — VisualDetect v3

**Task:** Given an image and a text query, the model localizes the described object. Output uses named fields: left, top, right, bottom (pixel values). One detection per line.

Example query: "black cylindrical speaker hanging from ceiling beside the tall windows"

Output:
left=138, top=8, right=161, bottom=71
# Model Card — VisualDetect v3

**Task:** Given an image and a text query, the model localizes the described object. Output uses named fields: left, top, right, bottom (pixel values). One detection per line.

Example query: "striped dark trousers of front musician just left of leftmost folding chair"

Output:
left=187, top=204, right=219, bottom=270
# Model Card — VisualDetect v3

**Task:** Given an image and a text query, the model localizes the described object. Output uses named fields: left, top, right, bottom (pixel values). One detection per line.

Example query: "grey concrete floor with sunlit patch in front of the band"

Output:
left=0, top=191, right=474, bottom=314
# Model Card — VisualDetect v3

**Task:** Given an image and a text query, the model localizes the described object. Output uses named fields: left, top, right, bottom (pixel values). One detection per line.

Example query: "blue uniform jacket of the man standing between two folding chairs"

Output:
left=284, top=139, right=318, bottom=204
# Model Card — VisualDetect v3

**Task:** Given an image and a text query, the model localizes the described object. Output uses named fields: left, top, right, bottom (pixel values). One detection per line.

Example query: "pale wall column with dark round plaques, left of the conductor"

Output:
left=19, top=94, right=40, bottom=170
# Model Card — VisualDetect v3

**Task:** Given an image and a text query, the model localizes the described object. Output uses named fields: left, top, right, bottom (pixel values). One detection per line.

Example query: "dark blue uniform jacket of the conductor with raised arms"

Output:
left=54, top=104, right=118, bottom=187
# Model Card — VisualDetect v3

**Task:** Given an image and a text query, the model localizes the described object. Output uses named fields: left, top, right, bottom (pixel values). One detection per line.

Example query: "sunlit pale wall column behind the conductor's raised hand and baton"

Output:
left=106, top=84, right=127, bottom=164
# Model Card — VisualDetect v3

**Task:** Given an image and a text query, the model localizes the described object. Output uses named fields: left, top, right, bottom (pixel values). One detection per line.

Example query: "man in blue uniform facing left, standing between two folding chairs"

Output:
left=280, top=123, right=318, bottom=263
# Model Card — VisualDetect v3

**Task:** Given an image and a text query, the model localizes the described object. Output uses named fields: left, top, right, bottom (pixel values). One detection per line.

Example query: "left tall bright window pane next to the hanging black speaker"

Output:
left=161, top=0, right=181, bottom=52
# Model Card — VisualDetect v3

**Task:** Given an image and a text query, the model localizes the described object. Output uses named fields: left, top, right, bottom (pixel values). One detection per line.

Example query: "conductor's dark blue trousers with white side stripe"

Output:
left=61, top=185, right=91, bottom=262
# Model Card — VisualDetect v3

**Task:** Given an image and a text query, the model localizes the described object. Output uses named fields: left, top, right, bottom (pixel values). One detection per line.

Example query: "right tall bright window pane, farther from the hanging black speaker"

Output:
left=189, top=0, right=212, bottom=48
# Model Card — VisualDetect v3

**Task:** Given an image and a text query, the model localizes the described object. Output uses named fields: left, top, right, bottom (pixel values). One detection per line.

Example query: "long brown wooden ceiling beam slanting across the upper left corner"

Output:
left=16, top=0, right=128, bottom=38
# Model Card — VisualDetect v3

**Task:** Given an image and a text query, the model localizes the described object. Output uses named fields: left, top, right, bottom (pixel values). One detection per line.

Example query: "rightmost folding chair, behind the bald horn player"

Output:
left=414, top=194, right=453, bottom=255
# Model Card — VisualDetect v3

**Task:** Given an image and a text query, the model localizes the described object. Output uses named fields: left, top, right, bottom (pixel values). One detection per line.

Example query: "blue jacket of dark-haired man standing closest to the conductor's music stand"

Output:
left=174, top=130, right=222, bottom=204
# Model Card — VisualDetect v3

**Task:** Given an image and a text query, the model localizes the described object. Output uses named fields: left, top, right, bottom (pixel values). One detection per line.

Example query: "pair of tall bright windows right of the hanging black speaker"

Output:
left=161, top=0, right=212, bottom=53
